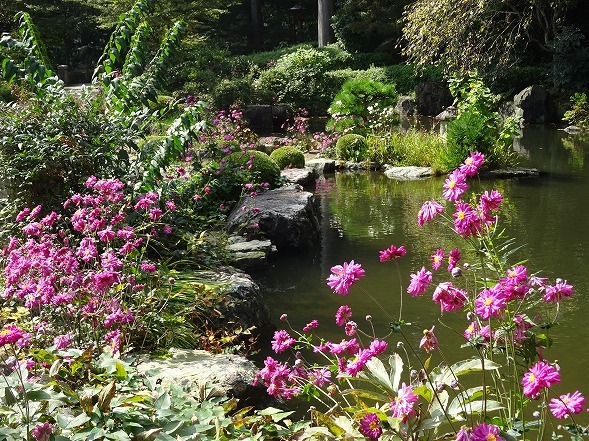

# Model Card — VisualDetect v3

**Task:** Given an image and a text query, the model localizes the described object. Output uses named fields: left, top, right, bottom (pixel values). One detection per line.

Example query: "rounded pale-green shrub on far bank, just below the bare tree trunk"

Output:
left=257, top=49, right=332, bottom=113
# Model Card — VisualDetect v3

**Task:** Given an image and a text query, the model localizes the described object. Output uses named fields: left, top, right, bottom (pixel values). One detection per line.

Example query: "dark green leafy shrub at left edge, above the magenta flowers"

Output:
left=0, top=92, right=137, bottom=209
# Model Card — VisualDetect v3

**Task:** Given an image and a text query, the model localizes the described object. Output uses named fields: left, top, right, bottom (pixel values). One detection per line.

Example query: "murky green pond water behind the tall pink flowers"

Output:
left=255, top=127, right=589, bottom=422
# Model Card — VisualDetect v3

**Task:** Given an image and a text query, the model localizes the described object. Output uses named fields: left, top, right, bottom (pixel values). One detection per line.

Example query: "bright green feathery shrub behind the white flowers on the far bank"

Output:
left=328, top=79, right=398, bottom=131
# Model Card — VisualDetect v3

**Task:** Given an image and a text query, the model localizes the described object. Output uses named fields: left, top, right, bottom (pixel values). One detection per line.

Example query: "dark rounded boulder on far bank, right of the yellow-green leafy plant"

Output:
left=513, top=84, right=556, bottom=124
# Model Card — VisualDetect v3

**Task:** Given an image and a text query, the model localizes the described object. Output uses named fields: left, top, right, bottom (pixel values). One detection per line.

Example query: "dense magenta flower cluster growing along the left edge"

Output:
left=2, top=176, right=175, bottom=351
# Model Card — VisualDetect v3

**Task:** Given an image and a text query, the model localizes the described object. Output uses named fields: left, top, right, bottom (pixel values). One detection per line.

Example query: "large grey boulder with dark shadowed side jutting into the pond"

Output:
left=227, top=185, right=320, bottom=251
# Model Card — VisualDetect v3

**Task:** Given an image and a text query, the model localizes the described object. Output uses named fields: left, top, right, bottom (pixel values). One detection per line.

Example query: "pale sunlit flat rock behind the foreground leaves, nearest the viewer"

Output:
left=137, top=348, right=263, bottom=404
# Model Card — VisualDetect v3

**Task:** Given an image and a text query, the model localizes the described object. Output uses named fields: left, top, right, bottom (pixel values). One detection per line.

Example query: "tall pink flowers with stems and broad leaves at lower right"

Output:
left=258, top=152, right=587, bottom=440
